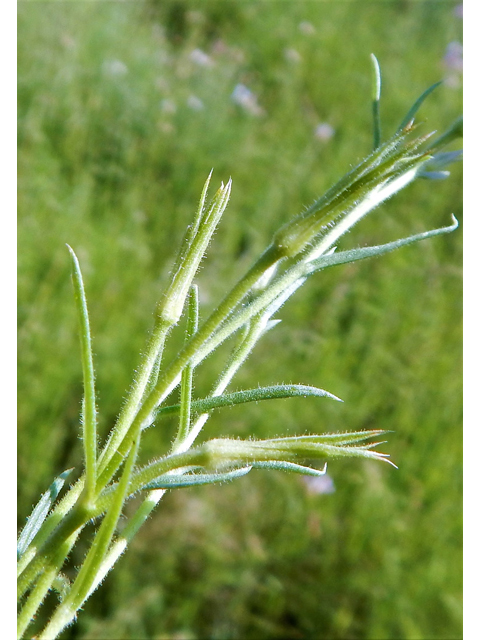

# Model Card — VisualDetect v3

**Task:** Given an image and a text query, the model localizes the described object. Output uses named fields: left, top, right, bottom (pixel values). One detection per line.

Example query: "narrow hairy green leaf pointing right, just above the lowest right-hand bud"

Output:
left=157, top=384, right=342, bottom=417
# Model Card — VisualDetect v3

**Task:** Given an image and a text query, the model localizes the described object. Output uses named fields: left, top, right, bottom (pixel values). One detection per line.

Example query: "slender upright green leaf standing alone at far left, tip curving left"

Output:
left=67, top=244, right=97, bottom=504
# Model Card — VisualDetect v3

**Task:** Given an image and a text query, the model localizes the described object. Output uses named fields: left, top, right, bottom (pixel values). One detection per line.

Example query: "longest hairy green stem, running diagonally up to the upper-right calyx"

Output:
left=97, top=133, right=425, bottom=490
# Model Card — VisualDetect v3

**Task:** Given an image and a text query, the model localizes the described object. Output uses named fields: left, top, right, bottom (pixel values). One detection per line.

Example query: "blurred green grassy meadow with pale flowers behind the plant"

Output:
left=18, top=0, right=462, bottom=640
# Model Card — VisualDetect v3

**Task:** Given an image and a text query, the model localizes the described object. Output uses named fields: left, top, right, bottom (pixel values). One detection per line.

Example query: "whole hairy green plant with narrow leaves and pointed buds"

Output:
left=17, top=55, right=462, bottom=640
